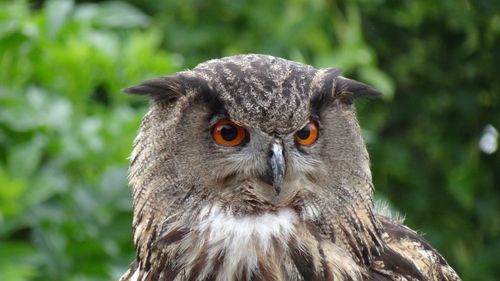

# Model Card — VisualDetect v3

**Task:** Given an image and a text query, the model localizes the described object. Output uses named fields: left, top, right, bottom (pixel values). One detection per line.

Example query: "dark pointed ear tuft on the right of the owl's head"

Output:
left=333, top=76, right=381, bottom=104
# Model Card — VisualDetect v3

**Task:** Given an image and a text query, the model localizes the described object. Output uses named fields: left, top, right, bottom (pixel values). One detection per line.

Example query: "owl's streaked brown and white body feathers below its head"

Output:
left=121, top=205, right=460, bottom=281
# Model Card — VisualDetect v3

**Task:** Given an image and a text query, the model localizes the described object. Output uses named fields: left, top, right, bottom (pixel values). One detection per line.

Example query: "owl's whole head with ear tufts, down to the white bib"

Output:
left=126, top=55, right=377, bottom=219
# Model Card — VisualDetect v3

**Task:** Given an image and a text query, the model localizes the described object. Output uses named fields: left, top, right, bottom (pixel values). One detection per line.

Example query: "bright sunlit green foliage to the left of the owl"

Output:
left=0, top=1, right=177, bottom=280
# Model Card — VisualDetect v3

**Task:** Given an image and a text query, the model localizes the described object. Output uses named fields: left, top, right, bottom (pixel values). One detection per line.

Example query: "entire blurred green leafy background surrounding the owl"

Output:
left=0, top=0, right=500, bottom=281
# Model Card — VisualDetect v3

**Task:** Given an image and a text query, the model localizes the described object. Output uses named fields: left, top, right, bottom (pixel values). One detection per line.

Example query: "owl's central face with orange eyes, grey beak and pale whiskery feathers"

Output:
left=208, top=113, right=319, bottom=209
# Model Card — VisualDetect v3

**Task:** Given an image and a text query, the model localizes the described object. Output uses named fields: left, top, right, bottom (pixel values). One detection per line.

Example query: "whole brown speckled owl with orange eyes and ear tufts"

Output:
left=121, top=54, right=460, bottom=281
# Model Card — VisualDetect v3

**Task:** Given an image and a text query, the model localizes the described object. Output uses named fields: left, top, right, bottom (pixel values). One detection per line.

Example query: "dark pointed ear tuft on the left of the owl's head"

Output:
left=123, top=74, right=186, bottom=101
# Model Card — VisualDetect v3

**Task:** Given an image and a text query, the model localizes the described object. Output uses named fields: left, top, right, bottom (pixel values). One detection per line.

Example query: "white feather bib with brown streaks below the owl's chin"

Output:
left=186, top=207, right=299, bottom=281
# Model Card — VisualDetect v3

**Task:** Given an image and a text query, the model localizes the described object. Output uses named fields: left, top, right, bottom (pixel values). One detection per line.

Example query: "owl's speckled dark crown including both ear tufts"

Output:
left=127, top=54, right=378, bottom=134
